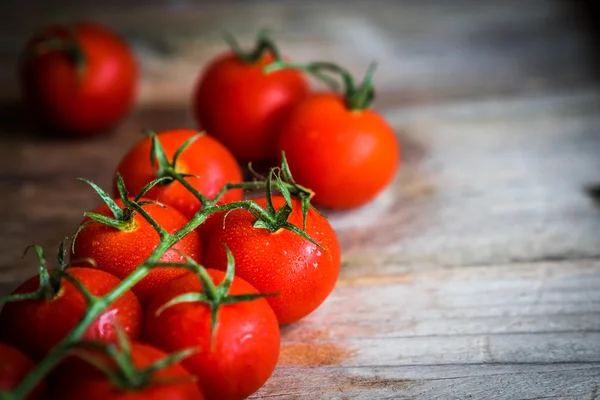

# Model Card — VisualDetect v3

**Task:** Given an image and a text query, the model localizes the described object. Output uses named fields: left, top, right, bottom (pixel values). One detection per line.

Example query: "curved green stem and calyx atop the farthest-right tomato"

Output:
left=263, top=61, right=377, bottom=111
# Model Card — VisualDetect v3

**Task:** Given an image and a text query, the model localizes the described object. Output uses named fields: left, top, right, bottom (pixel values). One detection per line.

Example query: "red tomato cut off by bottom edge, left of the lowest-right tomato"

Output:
left=52, top=342, right=204, bottom=400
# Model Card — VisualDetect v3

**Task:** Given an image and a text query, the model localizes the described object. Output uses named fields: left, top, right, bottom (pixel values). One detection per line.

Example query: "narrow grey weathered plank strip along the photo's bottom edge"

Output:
left=252, top=363, right=600, bottom=400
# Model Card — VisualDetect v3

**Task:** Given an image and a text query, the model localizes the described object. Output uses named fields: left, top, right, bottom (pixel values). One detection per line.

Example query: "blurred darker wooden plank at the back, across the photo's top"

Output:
left=0, top=0, right=594, bottom=105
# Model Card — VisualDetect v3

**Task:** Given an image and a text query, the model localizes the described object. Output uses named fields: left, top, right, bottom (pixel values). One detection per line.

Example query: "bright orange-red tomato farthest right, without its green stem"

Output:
left=277, top=93, right=400, bottom=209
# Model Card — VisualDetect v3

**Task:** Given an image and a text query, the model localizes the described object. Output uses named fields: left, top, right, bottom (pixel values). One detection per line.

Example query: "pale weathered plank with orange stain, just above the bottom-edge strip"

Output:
left=281, top=262, right=600, bottom=366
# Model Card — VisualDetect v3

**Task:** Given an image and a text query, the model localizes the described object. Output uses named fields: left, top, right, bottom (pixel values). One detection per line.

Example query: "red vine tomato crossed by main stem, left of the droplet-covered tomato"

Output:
left=71, top=199, right=202, bottom=305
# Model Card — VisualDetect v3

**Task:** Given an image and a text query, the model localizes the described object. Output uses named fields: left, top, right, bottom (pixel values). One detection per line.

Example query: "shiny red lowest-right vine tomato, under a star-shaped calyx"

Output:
left=144, top=270, right=280, bottom=400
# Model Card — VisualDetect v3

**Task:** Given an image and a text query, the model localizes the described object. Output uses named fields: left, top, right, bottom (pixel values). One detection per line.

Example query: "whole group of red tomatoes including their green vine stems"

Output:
left=0, top=23, right=399, bottom=399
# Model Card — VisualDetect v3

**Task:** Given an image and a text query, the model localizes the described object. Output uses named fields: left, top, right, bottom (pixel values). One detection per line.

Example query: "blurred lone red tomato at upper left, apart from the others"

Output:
left=20, top=22, right=138, bottom=135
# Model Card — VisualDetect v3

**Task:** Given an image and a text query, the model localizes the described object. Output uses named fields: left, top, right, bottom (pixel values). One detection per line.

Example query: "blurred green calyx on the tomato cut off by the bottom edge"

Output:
left=71, top=326, right=198, bottom=391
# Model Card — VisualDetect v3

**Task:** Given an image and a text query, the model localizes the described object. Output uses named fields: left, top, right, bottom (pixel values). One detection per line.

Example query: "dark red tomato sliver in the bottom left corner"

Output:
left=0, top=343, right=46, bottom=400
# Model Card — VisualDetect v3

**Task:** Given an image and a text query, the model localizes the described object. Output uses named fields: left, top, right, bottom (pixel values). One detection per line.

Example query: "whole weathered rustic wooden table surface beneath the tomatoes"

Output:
left=0, top=0, right=600, bottom=400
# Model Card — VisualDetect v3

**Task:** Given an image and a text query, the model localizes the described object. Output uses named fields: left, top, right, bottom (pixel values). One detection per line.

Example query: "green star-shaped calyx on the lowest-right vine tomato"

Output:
left=156, top=245, right=271, bottom=343
